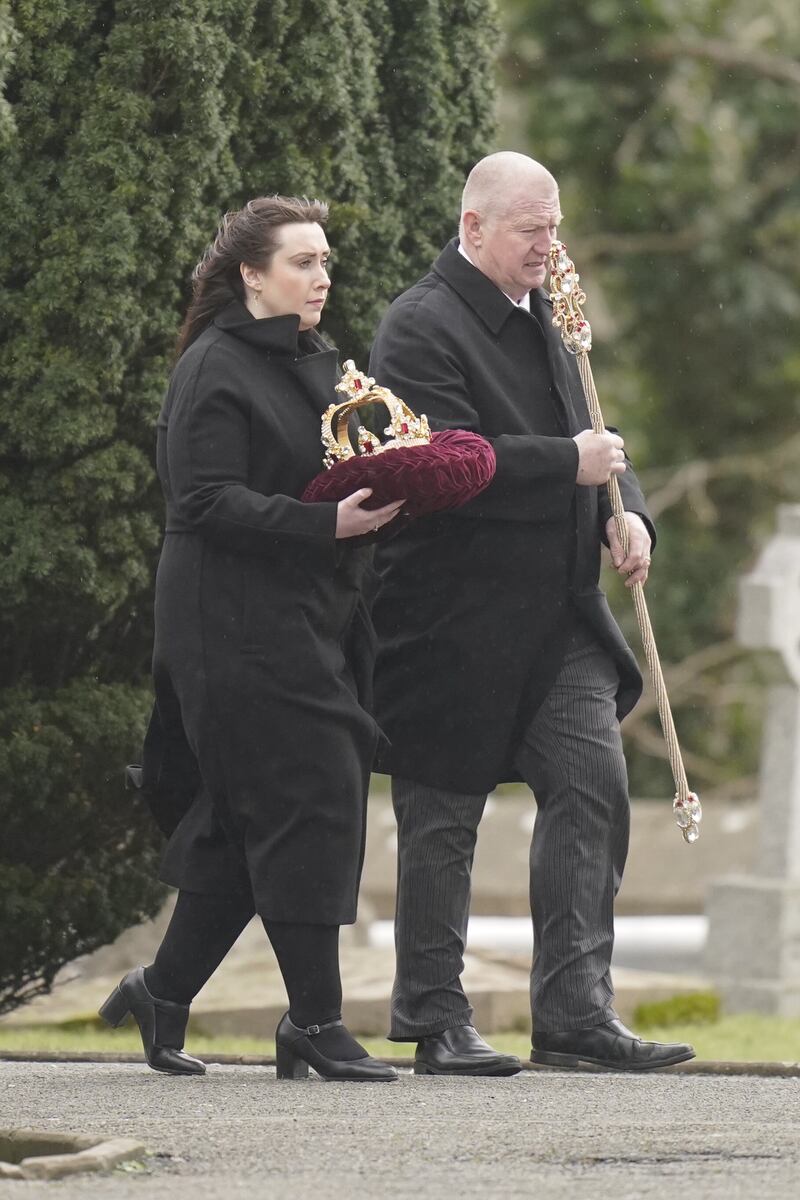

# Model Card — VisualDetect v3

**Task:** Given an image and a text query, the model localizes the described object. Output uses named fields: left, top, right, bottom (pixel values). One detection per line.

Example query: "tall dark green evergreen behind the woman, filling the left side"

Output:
left=0, top=0, right=493, bottom=1007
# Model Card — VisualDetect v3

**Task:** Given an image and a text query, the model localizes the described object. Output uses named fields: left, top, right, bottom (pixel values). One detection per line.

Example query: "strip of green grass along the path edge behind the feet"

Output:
left=0, top=1015, right=800, bottom=1062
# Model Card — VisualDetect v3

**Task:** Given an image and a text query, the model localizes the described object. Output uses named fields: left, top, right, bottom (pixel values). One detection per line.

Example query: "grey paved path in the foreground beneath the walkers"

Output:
left=0, top=1063, right=800, bottom=1200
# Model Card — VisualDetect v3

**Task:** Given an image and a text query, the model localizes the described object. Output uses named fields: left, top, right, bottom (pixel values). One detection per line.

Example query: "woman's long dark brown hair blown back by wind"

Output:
left=175, top=196, right=327, bottom=358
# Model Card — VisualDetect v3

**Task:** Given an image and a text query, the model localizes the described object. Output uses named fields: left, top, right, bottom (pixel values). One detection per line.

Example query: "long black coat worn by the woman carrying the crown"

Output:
left=144, top=302, right=378, bottom=924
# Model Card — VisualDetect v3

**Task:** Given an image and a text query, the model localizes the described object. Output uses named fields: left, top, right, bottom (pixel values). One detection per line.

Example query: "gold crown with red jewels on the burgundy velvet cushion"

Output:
left=323, top=359, right=431, bottom=467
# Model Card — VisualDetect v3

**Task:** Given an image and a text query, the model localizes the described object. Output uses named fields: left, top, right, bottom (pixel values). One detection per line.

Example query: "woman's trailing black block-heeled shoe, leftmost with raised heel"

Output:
left=100, top=967, right=205, bottom=1075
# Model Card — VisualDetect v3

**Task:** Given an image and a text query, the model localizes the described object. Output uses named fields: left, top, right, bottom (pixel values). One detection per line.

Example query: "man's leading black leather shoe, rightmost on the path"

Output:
left=530, top=1018, right=694, bottom=1070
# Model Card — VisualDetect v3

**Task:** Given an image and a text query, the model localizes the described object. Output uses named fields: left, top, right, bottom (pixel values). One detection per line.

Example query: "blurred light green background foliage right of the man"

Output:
left=504, top=0, right=800, bottom=796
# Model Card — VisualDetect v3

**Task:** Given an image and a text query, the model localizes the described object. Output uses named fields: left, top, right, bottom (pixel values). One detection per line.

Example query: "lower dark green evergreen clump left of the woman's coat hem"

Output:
left=0, top=679, right=163, bottom=1013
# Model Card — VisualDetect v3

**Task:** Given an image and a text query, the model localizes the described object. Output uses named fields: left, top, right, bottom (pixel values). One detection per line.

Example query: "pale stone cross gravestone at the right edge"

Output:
left=706, top=504, right=800, bottom=1016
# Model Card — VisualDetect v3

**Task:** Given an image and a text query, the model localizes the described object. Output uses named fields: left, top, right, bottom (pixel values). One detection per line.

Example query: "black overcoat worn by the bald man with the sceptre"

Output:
left=369, top=241, right=655, bottom=793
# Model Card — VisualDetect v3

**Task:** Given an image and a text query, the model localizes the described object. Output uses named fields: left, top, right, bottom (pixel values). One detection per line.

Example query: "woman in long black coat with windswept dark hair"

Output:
left=101, top=196, right=402, bottom=1080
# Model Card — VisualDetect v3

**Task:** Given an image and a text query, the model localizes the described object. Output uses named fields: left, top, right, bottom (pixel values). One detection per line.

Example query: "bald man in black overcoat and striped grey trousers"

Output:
left=369, top=152, right=693, bottom=1075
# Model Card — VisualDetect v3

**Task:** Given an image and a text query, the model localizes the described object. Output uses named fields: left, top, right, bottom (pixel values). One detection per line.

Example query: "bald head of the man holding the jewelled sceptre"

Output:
left=459, top=150, right=561, bottom=302
